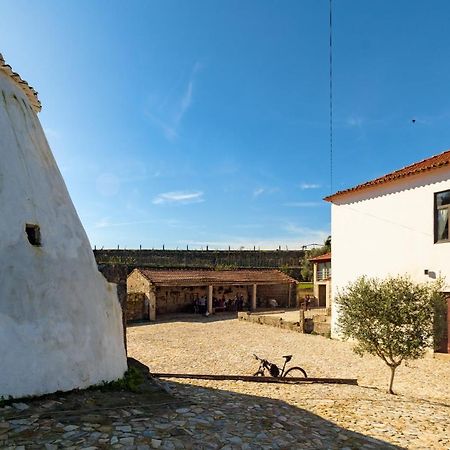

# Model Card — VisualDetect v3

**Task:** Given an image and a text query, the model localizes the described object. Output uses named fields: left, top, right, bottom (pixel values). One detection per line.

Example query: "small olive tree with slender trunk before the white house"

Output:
left=336, top=276, right=444, bottom=394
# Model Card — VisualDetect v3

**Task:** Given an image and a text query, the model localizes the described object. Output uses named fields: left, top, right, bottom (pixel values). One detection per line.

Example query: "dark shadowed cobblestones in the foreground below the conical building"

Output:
left=0, top=374, right=401, bottom=450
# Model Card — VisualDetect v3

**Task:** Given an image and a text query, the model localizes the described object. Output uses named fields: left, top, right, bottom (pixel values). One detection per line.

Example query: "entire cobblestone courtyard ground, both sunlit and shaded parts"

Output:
left=0, top=316, right=450, bottom=450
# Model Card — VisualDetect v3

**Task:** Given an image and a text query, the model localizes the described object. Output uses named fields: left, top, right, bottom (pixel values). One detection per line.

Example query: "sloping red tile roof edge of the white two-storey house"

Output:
left=324, top=150, right=450, bottom=202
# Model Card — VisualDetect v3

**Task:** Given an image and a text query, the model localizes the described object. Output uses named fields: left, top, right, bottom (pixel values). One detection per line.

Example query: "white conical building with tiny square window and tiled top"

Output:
left=0, top=55, right=126, bottom=397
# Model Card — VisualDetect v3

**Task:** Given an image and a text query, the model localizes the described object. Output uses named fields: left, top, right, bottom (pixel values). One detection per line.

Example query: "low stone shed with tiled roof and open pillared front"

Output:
left=127, top=269, right=297, bottom=321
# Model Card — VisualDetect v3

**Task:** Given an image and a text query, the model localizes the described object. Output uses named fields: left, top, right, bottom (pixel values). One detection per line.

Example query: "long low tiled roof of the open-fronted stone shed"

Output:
left=135, top=269, right=297, bottom=286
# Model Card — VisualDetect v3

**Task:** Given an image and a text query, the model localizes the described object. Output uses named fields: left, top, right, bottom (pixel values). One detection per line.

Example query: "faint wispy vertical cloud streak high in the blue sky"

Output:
left=146, top=62, right=202, bottom=141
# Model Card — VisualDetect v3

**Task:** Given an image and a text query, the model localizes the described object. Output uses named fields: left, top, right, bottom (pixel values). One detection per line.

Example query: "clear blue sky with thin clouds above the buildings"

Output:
left=0, top=0, right=450, bottom=248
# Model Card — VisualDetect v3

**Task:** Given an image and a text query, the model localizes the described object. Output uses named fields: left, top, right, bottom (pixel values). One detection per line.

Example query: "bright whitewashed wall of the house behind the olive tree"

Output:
left=331, top=167, right=450, bottom=337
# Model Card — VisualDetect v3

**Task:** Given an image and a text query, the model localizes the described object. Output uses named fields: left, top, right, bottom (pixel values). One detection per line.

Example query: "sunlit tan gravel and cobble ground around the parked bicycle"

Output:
left=128, top=316, right=450, bottom=449
